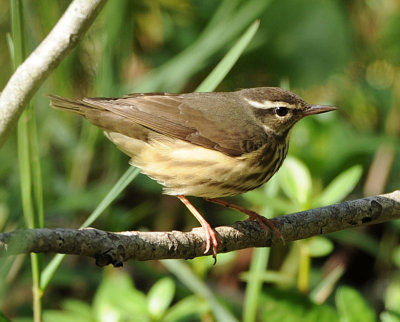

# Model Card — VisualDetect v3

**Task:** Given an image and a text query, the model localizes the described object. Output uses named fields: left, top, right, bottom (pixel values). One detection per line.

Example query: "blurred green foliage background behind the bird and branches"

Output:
left=0, top=0, right=400, bottom=322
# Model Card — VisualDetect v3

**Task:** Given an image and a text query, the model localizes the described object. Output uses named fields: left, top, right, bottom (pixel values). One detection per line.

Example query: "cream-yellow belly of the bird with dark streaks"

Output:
left=108, top=133, right=287, bottom=198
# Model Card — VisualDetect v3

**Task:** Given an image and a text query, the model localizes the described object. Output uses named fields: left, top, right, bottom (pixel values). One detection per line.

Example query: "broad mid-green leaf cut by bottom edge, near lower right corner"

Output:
left=335, top=286, right=376, bottom=322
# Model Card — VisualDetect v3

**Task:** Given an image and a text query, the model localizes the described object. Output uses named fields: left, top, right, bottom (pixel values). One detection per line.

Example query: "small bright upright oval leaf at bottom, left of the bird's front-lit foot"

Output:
left=147, top=277, right=175, bottom=320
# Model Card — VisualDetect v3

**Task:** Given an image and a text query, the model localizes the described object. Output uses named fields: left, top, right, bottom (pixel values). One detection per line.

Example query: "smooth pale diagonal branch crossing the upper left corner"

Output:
left=0, top=0, right=106, bottom=147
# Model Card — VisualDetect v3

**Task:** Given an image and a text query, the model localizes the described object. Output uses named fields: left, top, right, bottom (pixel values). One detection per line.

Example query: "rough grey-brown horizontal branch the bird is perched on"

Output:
left=0, top=190, right=400, bottom=266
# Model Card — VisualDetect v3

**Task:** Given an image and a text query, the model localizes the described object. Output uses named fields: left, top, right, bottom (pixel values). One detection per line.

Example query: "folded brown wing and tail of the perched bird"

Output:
left=51, top=92, right=267, bottom=156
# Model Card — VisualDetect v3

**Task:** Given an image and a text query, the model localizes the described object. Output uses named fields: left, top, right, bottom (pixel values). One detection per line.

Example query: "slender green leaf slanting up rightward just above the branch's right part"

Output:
left=314, top=165, right=362, bottom=207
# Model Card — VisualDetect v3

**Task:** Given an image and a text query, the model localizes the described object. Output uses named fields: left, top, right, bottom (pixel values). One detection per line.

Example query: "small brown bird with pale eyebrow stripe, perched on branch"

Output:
left=50, top=87, right=336, bottom=258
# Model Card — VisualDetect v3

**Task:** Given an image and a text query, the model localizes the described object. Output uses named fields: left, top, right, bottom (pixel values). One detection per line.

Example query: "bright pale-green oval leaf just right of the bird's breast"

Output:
left=279, top=156, right=311, bottom=208
